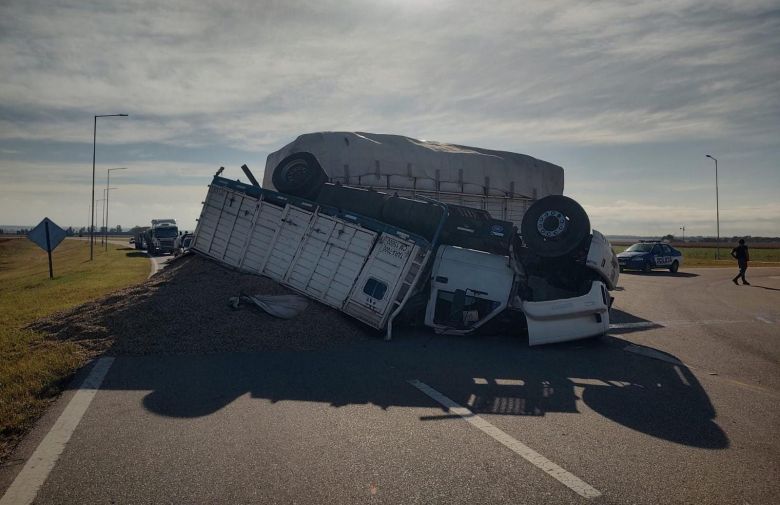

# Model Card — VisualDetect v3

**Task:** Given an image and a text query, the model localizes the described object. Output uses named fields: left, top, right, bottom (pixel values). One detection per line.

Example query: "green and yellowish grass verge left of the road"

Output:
left=0, top=237, right=150, bottom=460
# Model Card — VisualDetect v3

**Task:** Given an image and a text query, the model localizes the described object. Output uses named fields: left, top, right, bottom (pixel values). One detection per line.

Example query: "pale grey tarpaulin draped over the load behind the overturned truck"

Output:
left=263, top=132, right=563, bottom=199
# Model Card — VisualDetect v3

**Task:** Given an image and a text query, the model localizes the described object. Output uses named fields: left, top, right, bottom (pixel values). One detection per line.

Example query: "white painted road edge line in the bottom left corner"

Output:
left=0, top=357, right=114, bottom=505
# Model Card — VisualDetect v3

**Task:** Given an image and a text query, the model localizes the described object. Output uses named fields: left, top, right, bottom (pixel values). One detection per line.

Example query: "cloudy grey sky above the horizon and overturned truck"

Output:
left=0, top=0, right=780, bottom=236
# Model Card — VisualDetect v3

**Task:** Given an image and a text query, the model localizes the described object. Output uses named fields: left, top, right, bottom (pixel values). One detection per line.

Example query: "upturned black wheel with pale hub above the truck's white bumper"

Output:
left=520, top=195, right=590, bottom=258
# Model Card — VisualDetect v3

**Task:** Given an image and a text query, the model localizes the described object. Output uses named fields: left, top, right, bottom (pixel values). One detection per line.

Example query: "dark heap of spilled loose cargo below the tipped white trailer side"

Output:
left=30, top=255, right=372, bottom=355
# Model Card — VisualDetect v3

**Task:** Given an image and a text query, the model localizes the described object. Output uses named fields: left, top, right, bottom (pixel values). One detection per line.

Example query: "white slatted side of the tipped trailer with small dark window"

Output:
left=193, top=179, right=429, bottom=328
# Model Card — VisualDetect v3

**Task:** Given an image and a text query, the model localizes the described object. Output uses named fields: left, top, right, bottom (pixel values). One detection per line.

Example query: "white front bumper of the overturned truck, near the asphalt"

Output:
left=523, top=281, right=610, bottom=345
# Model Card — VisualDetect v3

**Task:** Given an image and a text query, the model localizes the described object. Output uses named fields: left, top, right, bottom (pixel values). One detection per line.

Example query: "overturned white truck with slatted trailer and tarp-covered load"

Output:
left=192, top=132, right=618, bottom=345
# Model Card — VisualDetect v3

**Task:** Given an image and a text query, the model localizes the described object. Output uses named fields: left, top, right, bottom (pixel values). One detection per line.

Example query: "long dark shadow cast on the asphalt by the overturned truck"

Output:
left=99, top=334, right=728, bottom=449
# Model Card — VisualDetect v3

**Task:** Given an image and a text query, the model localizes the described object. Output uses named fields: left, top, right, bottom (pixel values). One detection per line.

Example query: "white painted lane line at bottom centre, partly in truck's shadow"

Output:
left=408, top=379, right=601, bottom=498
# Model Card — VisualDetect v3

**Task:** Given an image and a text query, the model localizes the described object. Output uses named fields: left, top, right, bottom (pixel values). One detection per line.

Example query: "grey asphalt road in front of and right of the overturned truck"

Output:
left=0, top=269, right=780, bottom=504
